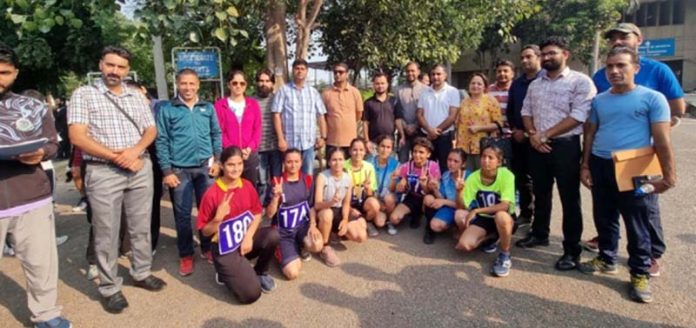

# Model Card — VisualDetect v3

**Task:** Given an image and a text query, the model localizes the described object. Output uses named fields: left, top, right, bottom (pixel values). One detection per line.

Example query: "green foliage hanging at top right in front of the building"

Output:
left=514, top=0, right=629, bottom=64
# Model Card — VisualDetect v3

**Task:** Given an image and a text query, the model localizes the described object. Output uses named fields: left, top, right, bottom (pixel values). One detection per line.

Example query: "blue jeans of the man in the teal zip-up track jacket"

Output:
left=169, top=165, right=213, bottom=257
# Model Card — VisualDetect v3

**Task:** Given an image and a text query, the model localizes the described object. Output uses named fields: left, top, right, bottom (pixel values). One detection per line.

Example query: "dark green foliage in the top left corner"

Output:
left=0, top=0, right=152, bottom=95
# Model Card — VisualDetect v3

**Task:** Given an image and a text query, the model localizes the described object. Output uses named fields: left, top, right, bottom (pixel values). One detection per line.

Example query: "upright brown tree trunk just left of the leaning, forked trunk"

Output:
left=264, top=0, right=289, bottom=90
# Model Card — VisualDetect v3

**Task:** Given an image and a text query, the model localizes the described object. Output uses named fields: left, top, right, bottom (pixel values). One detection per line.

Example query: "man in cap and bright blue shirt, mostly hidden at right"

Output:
left=583, top=23, right=686, bottom=276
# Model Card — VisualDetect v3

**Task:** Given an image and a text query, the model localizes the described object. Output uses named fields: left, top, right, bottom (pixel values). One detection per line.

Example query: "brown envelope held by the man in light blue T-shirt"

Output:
left=611, top=146, right=662, bottom=191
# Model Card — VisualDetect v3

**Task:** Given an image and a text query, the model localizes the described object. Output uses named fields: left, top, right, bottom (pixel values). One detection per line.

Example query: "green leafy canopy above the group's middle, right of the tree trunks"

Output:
left=320, top=0, right=534, bottom=71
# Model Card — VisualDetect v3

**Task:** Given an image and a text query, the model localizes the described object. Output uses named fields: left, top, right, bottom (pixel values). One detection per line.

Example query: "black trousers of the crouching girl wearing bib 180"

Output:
left=211, top=227, right=280, bottom=304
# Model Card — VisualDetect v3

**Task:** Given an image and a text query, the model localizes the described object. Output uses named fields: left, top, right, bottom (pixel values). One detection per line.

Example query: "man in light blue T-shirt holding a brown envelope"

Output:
left=579, top=47, right=677, bottom=303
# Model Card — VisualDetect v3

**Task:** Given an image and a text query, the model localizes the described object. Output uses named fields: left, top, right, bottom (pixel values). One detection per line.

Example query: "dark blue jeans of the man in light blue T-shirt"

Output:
left=590, top=155, right=659, bottom=275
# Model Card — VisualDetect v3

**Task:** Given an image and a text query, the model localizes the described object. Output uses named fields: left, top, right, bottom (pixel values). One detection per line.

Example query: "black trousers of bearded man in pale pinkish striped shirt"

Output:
left=529, top=136, right=582, bottom=256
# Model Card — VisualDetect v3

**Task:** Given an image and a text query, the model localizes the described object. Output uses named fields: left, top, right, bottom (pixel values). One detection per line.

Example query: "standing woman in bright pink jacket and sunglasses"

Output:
left=215, top=70, right=261, bottom=186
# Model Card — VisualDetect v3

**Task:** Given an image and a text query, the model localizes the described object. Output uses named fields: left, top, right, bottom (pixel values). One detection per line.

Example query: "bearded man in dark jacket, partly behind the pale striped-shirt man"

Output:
left=506, top=44, right=541, bottom=226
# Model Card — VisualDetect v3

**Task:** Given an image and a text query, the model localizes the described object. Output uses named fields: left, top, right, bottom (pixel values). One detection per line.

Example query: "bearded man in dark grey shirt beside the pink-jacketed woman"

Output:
left=253, top=68, right=282, bottom=195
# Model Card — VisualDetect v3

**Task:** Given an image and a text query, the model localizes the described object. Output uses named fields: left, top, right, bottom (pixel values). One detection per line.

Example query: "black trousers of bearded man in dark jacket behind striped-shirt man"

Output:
left=510, top=139, right=534, bottom=219
